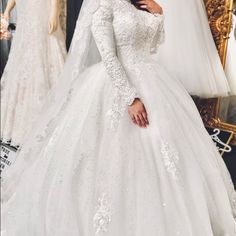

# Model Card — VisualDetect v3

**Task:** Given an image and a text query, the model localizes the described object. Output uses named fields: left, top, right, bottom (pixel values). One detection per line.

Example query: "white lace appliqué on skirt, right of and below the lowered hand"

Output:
left=161, top=142, right=179, bottom=180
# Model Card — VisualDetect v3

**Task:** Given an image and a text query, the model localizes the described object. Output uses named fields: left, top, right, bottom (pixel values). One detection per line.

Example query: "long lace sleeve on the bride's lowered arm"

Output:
left=92, top=0, right=138, bottom=129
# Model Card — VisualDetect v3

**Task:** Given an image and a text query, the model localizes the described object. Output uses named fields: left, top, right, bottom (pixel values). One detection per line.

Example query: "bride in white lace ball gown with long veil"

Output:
left=2, top=0, right=236, bottom=236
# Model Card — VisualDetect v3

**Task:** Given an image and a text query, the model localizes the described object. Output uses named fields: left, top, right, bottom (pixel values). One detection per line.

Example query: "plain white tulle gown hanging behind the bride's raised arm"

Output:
left=157, top=0, right=232, bottom=97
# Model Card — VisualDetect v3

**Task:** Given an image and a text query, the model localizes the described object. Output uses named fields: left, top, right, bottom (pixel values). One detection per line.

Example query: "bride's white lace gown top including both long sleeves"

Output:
left=92, top=0, right=164, bottom=128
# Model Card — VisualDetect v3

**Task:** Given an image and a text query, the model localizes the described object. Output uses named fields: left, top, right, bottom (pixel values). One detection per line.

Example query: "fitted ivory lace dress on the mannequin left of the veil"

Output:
left=1, top=0, right=66, bottom=146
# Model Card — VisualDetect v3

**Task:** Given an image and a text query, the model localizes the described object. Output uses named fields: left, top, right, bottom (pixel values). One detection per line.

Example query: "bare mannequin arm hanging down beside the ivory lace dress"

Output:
left=49, top=0, right=60, bottom=34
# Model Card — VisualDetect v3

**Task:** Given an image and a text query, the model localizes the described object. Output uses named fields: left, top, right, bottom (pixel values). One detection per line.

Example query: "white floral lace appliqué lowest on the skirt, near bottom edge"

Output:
left=93, top=194, right=111, bottom=234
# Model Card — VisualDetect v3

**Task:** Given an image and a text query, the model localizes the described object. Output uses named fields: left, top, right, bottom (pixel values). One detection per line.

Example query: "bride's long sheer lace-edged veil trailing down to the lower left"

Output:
left=2, top=0, right=101, bottom=201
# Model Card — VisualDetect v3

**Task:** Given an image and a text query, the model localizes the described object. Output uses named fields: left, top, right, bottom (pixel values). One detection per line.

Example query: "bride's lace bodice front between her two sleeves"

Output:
left=113, top=0, right=163, bottom=65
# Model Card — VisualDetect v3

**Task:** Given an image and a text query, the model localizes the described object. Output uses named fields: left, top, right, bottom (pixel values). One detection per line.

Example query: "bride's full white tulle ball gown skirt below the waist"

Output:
left=2, top=59, right=235, bottom=236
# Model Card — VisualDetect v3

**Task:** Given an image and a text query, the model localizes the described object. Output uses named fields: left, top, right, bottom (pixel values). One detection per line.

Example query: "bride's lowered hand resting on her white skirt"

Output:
left=128, top=98, right=149, bottom=128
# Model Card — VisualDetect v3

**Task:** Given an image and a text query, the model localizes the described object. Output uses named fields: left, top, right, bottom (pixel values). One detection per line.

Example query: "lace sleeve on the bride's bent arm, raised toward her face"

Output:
left=150, top=15, right=165, bottom=53
